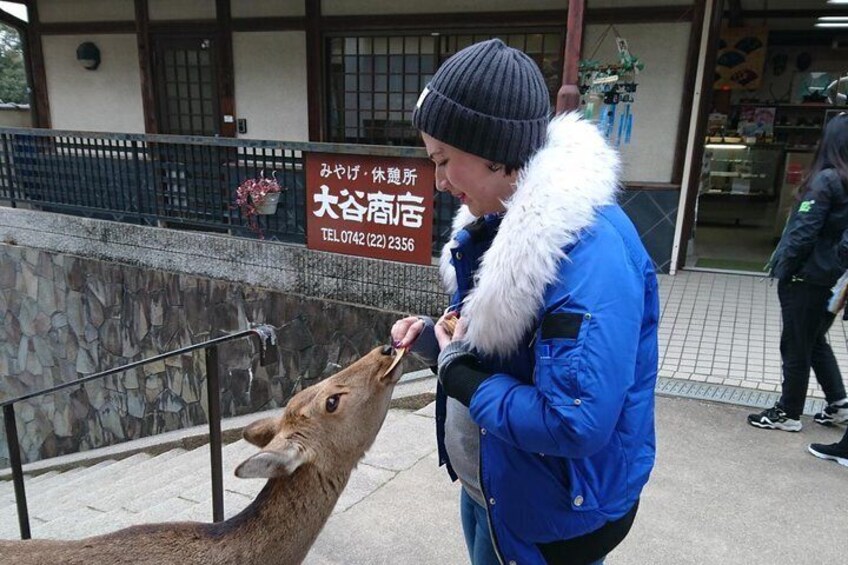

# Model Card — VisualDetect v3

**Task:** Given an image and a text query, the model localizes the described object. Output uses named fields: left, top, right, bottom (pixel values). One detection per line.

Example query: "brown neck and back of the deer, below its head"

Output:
left=0, top=467, right=351, bottom=565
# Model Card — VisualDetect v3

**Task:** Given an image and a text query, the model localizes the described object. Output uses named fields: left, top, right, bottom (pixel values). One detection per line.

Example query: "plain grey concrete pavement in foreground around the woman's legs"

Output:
left=307, top=397, right=848, bottom=565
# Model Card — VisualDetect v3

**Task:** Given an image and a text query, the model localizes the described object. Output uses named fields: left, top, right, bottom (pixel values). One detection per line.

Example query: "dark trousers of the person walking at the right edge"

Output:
left=777, top=280, right=845, bottom=419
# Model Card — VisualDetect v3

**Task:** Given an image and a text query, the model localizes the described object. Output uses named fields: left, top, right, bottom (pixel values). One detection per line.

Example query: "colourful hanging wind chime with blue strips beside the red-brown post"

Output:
left=579, top=25, right=645, bottom=147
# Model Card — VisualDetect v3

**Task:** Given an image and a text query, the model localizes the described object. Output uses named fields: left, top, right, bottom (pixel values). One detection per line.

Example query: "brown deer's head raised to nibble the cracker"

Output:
left=236, top=346, right=401, bottom=478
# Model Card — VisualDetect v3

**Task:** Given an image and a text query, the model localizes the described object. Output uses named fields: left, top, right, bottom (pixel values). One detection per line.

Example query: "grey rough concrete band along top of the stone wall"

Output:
left=0, top=207, right=448, bottom=316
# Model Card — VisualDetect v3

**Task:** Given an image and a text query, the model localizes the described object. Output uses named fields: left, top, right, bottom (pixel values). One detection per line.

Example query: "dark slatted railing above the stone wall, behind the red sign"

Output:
left=0, top=128, right=455, bottom=251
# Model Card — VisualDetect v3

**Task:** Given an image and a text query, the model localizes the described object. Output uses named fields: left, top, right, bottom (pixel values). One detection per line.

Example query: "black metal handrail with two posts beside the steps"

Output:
left=0, top=324, right=277, bottom=539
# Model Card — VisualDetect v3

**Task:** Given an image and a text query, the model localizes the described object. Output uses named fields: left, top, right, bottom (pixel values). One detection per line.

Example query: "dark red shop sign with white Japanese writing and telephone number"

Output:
left=306, top=153, right=435, bottom=265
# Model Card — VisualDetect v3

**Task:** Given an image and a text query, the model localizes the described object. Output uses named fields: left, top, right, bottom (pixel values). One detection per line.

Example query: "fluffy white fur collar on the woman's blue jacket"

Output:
left=439, top=113, right=619, bottom=357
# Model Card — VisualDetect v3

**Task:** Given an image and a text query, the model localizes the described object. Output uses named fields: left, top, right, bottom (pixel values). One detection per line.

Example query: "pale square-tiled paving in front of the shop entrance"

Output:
left=659, top=271, right=848, bottom=413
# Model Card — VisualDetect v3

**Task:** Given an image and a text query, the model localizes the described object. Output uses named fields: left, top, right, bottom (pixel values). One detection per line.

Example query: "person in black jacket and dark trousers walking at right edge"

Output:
left=748, top=112, right=848, bottom=432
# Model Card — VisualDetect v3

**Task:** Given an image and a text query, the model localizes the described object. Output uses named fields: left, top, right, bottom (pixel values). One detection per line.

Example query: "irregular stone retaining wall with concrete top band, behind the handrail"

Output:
left=0, top=208, right=444, bottom=467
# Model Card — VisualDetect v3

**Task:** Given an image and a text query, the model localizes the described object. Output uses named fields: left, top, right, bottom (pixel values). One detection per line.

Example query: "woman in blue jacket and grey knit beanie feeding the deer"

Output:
left=392, top=40, right=659, bottom=565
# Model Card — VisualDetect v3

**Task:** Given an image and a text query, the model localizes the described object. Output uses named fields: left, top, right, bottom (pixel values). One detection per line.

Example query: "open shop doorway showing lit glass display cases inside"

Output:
left=685, top=0, right=848, bottom=273
